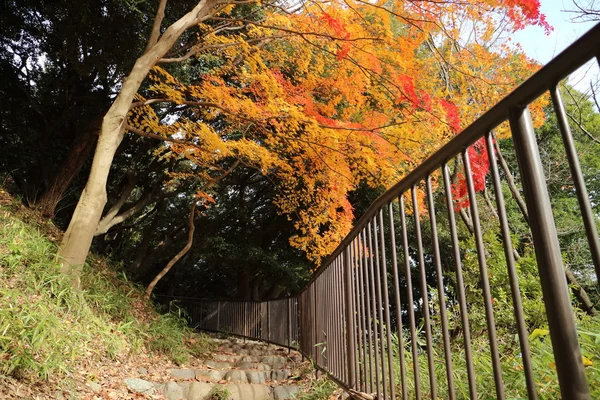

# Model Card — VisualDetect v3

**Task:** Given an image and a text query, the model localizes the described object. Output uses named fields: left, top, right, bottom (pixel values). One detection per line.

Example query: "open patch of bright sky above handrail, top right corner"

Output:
left=513, top=0, right=595, bottom=64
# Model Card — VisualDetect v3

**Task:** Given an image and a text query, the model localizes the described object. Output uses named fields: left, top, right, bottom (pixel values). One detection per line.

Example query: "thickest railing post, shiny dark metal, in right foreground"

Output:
left=510, top=108, right=591, bottom=400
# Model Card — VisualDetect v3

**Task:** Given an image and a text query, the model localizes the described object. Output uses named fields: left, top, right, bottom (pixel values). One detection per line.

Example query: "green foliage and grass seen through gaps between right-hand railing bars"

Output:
left=380, top=83, right=600, bottom=400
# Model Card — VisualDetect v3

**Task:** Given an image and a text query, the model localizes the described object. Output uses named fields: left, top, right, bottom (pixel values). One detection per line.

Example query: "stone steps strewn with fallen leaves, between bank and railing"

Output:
left=124, top=338, right=312, bottom=400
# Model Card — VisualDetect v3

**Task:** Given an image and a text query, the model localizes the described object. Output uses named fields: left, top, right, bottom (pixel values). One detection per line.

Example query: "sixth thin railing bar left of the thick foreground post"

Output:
left=398, top=194, right=421, bottom=400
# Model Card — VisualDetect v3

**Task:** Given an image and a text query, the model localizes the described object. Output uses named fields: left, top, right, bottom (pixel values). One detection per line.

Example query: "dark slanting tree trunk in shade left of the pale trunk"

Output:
left=36, top=118, right=101, bottom=218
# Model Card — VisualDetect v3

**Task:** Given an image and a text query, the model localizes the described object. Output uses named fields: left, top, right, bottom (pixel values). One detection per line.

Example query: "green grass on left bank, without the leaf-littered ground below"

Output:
left=0, top=207, right=214, bottom=379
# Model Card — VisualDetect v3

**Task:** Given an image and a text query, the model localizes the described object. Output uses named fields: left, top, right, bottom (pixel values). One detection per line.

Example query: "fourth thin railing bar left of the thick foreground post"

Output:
left=426, top=176, right=456, bottom=400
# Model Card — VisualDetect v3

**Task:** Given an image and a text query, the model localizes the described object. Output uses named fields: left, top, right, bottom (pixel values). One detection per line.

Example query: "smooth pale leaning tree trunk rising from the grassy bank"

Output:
left=58, top=0, right=217, bottom=287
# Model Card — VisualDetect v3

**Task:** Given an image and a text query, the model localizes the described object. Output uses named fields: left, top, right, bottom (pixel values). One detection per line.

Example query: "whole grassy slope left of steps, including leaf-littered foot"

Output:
left=0, top=188, right=216, bottom=398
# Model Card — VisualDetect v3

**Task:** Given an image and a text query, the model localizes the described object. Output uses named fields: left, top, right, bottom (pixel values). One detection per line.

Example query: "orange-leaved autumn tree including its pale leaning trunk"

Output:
left=59, top=0, right=549, bottom=284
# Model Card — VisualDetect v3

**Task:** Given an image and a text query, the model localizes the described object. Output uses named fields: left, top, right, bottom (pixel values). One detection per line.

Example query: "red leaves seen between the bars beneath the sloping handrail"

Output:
left=451, top=138, right=490, bottom=212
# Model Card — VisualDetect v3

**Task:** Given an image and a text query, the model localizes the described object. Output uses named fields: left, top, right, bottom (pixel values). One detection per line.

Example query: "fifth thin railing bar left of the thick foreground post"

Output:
left=411, top=186, right=437, bottom=399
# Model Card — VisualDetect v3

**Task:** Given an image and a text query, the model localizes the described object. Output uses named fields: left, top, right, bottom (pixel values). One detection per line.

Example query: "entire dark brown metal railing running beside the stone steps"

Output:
left=162, top=25, right=600, bottom=400
